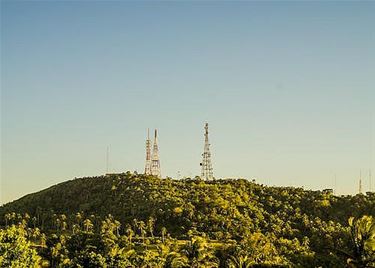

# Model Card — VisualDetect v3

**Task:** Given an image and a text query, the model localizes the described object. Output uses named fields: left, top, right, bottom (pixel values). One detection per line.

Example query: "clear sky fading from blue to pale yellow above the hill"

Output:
left=0, top=1, right=375, bottom=203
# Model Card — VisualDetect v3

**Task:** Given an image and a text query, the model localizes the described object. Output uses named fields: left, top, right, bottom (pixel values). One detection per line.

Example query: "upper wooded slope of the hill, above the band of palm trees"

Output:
left=0, top=172, right=375, bottom=228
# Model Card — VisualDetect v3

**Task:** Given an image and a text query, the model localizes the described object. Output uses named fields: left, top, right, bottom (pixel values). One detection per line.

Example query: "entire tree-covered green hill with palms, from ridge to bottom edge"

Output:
left=0, top=172, right=375, bottom=267
